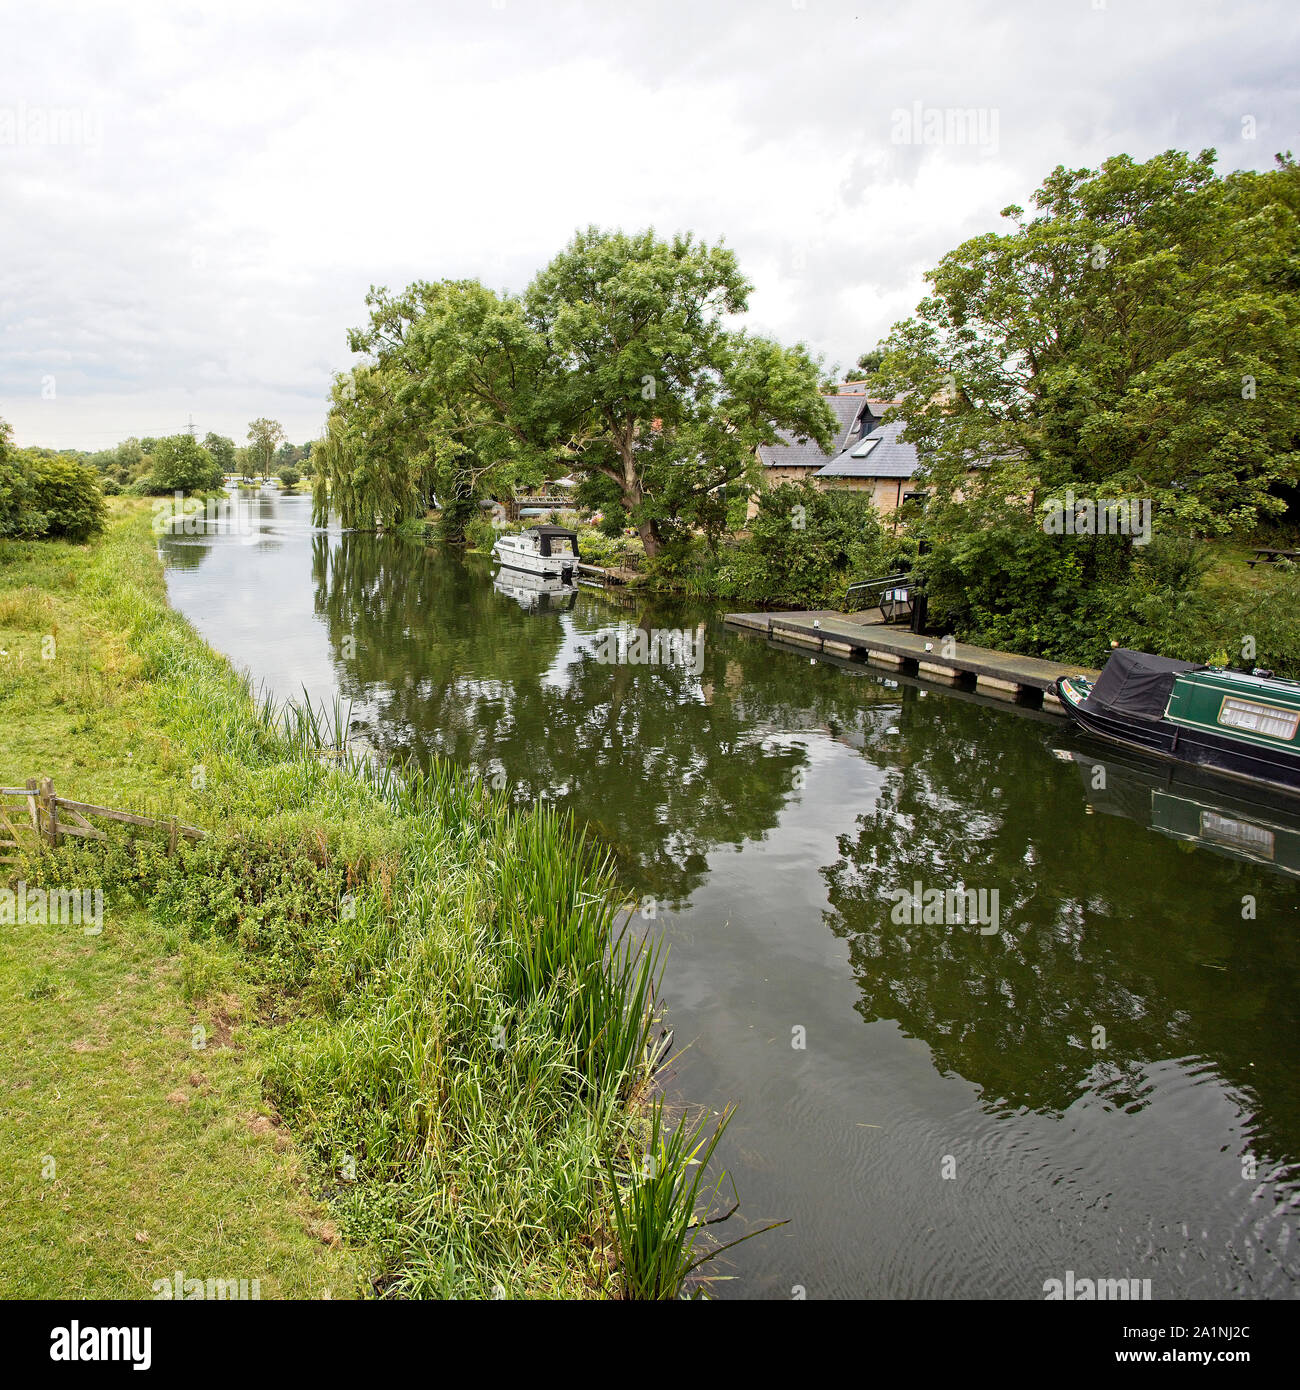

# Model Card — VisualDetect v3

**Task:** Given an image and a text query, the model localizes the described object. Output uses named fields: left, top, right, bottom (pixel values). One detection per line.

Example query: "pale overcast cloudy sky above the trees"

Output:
left=0, top=0, right=1300, bottom=449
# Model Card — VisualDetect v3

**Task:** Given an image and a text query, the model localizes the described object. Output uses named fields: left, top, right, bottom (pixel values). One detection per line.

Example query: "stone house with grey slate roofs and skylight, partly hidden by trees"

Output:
left=758, top=381, right=919, bottom=513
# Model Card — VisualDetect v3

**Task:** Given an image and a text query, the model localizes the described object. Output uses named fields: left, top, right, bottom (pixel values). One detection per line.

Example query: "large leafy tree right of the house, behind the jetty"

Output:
left=880, top=150, right=1300, bottom=659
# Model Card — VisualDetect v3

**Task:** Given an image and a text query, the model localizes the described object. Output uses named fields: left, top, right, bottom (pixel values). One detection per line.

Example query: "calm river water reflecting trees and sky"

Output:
left=163, top=492, right=1300, bottom=1298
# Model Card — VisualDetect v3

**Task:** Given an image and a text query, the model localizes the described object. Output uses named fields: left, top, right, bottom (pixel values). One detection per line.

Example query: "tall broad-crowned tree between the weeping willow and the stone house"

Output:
left=524, top=227, right=834, bottom=557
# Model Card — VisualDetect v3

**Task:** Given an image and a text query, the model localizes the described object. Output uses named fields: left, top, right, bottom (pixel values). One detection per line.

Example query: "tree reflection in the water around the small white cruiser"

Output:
left=313, top=535, right=823, bottom=904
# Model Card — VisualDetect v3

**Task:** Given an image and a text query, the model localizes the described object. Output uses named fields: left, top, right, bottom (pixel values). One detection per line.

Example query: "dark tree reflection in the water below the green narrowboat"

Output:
left=823, top=691, right=1300, bottom=1152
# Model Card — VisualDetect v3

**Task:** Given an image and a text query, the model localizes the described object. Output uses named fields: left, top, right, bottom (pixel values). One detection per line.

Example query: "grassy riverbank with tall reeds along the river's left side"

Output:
left=0, top=500, right=700, bottom=1297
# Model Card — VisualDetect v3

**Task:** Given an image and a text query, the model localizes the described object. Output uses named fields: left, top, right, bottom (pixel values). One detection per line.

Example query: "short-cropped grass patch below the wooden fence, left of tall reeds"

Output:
left=0, top=913, right=355, bottom=1298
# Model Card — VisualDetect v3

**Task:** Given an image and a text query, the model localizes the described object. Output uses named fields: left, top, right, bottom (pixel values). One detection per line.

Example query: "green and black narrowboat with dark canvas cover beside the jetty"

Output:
left=1051, top=648, right=1300, bottom=795
